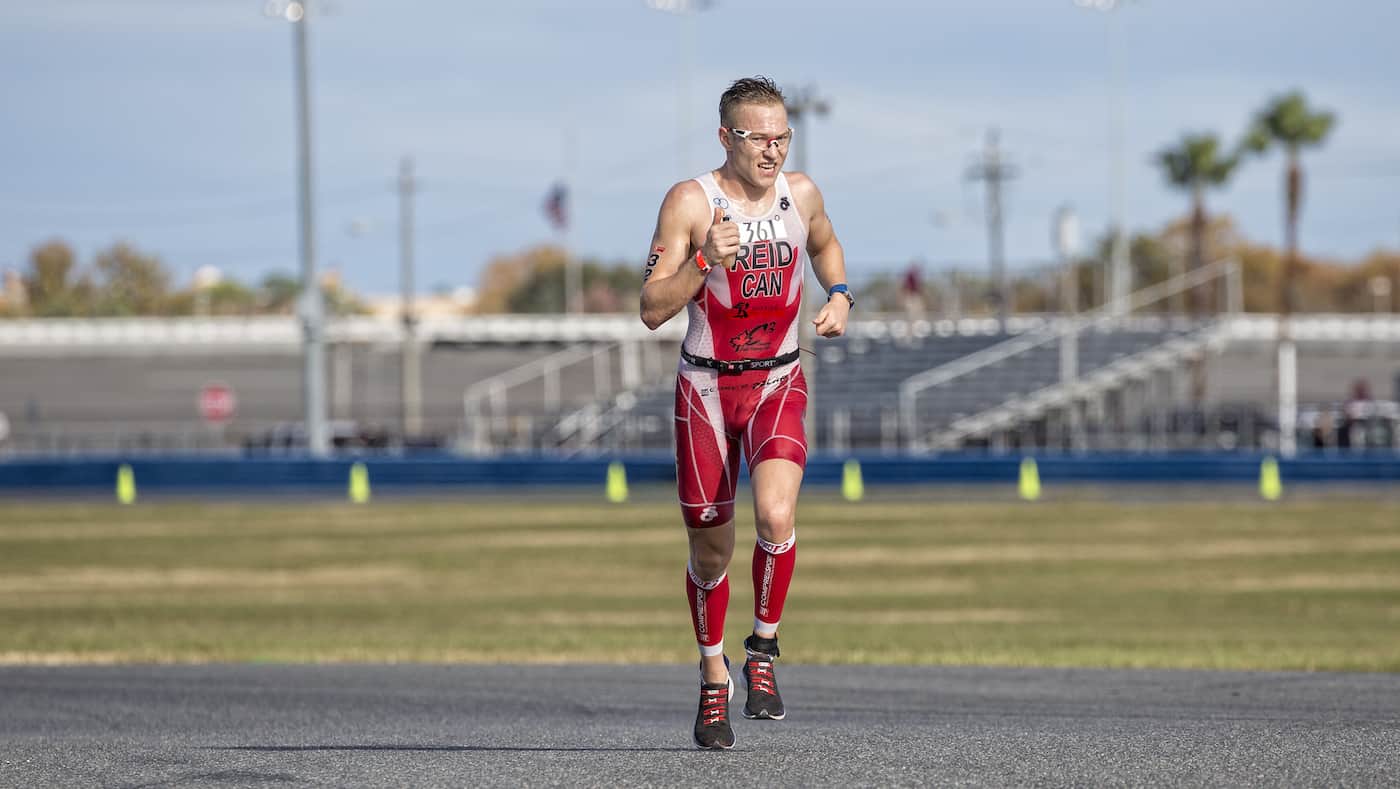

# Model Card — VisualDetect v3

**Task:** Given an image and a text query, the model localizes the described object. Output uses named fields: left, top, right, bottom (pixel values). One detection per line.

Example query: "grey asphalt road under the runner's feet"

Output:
left=0, top=664, right=1400, bottom=786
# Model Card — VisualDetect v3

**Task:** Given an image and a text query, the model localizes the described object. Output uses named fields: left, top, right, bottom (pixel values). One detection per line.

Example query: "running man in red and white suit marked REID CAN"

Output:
left=641, top=77, right=855, bottom=748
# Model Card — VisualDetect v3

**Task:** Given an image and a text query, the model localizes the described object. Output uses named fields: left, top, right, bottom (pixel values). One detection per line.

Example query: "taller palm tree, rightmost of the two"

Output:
left=1245, top=91, right=1337, bottom=315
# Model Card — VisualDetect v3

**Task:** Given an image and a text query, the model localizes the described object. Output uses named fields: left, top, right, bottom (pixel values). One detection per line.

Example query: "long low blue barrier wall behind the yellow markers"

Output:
left=0, top=453, right=1400, bottom=494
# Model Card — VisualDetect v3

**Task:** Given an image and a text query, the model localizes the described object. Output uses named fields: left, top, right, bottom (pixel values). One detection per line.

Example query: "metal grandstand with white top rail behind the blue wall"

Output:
left=0, top=271, right=1400, bottom=455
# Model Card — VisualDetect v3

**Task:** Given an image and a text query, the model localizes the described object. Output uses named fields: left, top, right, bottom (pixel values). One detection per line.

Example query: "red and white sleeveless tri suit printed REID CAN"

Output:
left=676, top=172, right=806, bottom=527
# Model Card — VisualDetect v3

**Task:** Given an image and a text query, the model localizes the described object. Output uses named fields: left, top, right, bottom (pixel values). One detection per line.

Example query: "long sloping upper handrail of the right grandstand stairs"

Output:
left=899, top=260, right=1243, bottom=452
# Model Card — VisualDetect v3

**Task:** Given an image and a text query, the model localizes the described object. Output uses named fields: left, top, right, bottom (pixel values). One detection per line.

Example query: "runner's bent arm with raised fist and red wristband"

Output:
left=641, top=180, right=739, bottom=330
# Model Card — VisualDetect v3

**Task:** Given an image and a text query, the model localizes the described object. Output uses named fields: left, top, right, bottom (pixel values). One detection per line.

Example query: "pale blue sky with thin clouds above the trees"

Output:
left=0, top=0, right=1400, bottom=292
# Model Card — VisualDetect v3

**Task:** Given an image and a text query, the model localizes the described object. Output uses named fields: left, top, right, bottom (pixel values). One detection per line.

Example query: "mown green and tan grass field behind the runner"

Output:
left=0, top=490, right=1400, bottom=671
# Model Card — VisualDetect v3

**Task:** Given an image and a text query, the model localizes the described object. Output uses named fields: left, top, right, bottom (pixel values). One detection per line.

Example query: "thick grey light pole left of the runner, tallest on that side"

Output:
left=263, top=0, right=330, bottom=457
